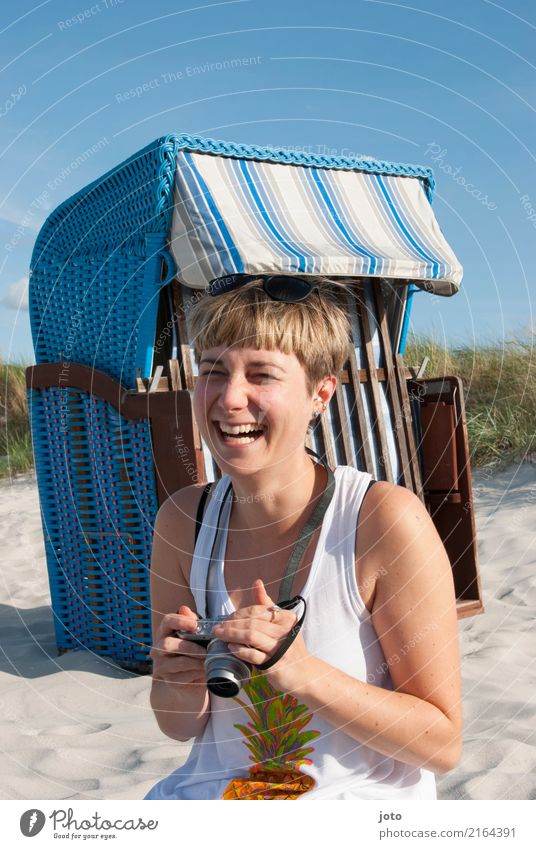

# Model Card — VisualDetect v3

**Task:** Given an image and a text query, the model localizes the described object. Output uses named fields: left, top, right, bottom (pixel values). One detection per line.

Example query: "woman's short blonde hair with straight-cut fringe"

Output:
left=189, top=278, right=350, bottom=394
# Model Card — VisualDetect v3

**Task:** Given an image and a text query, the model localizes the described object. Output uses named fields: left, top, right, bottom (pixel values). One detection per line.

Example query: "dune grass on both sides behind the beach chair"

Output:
left=0, top=336, right=536, bottom=477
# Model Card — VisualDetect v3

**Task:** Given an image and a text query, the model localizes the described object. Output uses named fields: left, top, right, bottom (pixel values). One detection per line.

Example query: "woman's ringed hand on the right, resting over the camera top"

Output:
left=209, top=578, right=310, bottom=693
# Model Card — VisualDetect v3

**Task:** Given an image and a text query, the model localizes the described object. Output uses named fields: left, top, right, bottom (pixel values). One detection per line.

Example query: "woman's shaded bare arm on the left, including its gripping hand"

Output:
left=151, top=487, right=210, bottom=740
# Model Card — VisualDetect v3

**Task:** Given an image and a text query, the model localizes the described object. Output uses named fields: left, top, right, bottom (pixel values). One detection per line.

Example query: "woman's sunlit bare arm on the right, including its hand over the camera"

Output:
left=218, top=484, right=462, bottom=773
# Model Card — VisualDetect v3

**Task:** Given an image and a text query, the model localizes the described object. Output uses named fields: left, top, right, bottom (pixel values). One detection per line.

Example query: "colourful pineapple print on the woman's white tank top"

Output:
left=222, top=669, right=320, bottom=799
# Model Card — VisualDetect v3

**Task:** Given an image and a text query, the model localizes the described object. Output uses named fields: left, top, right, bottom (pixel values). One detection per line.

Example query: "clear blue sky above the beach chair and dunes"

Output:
left=0, top=0, right=536, bottom=361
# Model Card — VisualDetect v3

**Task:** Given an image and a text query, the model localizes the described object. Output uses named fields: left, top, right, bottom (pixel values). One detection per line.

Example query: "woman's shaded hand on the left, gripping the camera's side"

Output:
left=149, top=605, right=207, bottom=686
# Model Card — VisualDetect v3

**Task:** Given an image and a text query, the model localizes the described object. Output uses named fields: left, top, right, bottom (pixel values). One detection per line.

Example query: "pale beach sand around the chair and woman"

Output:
left=0, top=465, right=536, bottom=799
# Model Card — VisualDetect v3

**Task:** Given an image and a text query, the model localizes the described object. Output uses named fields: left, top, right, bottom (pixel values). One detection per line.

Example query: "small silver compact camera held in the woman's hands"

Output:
left=175, top=616, right=251, bottom=699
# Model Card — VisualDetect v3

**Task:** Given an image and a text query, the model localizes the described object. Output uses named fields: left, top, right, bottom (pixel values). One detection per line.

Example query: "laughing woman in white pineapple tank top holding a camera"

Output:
left=146, top=278, right=461, bottom=800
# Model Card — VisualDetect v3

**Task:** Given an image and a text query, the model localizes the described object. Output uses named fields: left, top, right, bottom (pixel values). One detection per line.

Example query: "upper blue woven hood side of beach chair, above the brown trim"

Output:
left=30, top=140, right=175, bottom=388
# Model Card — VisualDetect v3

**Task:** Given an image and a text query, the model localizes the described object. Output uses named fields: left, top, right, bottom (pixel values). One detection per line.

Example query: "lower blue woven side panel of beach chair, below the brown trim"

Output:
left=28, top=387, right=157, bottom=666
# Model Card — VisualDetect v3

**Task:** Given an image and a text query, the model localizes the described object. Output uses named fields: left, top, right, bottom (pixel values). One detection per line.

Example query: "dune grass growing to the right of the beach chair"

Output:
left=404, top=336, right=536, bottom=468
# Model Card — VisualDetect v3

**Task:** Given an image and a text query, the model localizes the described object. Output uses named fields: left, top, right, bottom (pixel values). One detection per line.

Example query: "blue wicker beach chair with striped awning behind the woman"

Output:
left=27, top=136, right=482, bottom=670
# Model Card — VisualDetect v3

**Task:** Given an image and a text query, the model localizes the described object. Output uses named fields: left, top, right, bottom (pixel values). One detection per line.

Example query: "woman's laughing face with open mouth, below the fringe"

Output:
left=193, top=345, right=331, bottom=476
